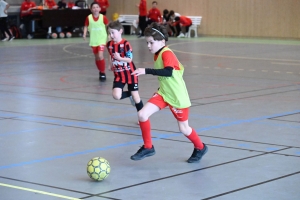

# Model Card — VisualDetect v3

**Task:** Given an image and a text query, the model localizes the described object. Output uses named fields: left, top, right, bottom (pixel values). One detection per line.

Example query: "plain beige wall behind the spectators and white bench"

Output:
left=107, top=0, right=300, bottom=39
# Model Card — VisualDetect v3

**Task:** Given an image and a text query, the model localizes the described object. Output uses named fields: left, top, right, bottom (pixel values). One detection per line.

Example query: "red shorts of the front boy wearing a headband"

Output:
left=148, top=93, right=189, bottom=122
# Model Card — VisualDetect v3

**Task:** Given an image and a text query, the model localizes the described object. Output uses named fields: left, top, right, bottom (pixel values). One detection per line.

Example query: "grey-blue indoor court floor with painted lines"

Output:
left=0, top=36, right=300, bottom=200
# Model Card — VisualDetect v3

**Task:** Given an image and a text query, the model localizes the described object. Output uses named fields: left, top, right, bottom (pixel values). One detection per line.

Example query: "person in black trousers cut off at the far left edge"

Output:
left=0, top=0, right=14, bottom=41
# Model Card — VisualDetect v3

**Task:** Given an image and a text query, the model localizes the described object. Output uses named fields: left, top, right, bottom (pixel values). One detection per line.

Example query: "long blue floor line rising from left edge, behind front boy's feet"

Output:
left=0, top=110, right=300, bottom=170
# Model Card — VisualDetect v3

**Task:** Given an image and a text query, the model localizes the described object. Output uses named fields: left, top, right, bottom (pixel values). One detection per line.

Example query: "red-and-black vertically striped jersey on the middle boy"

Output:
left=106, top=39, right=138, bottom=84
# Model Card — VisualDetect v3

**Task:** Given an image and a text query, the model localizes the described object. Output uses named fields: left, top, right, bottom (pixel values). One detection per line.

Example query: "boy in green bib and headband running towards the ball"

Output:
left=131, top=23, right=208, bottom=163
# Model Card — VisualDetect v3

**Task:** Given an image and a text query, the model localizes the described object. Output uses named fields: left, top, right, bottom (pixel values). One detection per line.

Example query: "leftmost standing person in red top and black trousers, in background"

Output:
left=20, top=0, right=37, bottom=39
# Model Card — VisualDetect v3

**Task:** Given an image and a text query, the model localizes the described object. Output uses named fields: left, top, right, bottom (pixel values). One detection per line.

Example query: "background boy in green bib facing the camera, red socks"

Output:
left=83, top=2, right=108, bottom=81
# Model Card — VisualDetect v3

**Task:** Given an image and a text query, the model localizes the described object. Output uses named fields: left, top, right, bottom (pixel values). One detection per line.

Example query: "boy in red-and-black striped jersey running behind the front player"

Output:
left=106, top=21, right=143, bottom=111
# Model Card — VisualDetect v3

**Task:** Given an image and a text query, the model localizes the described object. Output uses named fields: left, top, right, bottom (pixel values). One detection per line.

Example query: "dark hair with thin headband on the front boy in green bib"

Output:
left=144, top=22, right=169, bottom=41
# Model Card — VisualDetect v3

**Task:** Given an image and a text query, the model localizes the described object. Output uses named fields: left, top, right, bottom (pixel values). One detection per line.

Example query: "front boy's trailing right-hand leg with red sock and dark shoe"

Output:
left=170, top=106, right=207, bottom=163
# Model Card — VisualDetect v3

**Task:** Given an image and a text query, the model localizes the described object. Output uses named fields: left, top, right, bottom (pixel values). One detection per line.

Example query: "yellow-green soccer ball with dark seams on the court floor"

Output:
left=87, top=157, right=110, bottom=181
